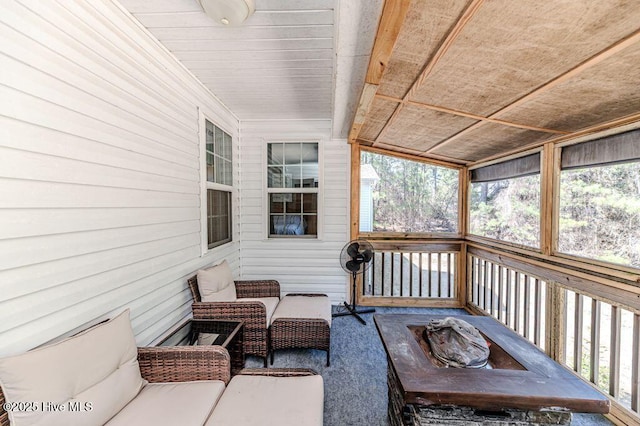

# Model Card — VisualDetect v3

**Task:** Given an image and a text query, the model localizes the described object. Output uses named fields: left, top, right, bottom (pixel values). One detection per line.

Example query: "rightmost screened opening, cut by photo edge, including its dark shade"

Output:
left=558, top=130, right=640, bottom=268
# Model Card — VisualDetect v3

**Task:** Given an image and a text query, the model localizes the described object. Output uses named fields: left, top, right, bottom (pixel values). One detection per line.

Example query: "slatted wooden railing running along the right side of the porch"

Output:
left=467, top=246, right=640, bottom=424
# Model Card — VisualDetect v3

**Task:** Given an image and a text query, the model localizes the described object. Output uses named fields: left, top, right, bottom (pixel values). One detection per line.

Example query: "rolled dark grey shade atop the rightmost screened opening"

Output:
left=561, top=129, right=640, bottom=170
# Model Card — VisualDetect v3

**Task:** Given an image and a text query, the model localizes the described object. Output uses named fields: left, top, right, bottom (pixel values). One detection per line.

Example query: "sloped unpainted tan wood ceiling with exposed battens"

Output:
left=349, top=0, right=640, bottom=164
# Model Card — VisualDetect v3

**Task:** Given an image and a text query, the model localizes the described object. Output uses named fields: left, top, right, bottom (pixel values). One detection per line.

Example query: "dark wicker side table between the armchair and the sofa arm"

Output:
left=158, top=319, right=245, bottom=375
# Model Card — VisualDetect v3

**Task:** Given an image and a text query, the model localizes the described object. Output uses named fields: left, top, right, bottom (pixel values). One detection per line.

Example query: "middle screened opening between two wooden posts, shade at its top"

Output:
left=469, top=153, right=540, bottom=248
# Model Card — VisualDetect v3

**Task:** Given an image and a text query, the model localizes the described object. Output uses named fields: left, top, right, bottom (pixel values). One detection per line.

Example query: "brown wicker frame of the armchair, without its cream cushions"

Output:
left=188, top=275, right=280, bottom=367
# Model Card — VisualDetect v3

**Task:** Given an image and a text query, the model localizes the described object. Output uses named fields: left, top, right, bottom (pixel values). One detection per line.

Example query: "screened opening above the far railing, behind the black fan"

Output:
left=360, top=151, right=459, bottom=233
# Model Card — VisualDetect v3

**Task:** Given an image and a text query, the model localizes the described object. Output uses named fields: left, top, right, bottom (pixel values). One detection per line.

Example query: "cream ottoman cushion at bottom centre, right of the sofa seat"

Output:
left=206, top=375, right=324, bottom=426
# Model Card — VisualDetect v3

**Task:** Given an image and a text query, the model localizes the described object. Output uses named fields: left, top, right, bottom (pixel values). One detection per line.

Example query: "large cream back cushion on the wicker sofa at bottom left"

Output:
left=0, top=310, right=146, bottom=426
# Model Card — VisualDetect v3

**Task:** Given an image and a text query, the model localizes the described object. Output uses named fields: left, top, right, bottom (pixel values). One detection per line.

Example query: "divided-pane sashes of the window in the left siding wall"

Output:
left=205, top=119, right=233, bottom=248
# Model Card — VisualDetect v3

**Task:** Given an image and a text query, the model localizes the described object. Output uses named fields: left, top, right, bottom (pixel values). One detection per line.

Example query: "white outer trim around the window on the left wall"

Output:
left=198, top=108, right=237, bottom=256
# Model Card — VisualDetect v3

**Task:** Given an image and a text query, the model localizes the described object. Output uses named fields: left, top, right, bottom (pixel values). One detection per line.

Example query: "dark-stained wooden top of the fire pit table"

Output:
left=374, top=314, right=610, bottom=413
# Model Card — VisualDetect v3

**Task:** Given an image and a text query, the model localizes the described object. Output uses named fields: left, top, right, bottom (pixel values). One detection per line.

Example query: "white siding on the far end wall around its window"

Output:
left=240, top=120, right=350, bottom=304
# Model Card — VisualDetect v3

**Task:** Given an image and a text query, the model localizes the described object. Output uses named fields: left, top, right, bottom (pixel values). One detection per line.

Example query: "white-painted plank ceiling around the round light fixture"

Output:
left=120, top=0, right=336, bottom=120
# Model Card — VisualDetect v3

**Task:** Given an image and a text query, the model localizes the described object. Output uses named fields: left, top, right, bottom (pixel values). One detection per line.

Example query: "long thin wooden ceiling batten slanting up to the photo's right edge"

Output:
left=425, top=30, right=640, bottom=154
